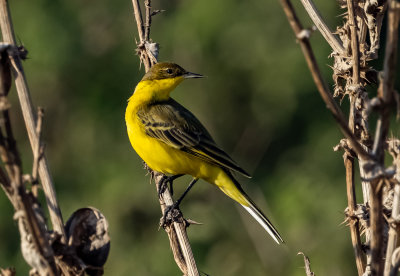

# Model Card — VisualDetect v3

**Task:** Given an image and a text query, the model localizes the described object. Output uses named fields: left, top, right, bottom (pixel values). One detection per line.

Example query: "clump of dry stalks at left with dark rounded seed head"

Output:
left=0, top=0, right=109, bottom=276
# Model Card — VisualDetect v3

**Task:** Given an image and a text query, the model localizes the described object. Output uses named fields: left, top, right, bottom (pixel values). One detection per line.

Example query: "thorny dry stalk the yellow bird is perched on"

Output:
left=132, top=0, right=199, bottom=276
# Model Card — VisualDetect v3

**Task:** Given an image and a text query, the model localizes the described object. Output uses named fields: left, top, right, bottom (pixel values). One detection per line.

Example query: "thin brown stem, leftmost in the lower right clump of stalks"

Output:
left=343, top=152, right=366, bottom=276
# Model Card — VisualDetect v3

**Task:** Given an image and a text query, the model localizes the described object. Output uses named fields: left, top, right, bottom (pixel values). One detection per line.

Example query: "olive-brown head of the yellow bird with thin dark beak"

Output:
left=141, top=62, right=204, bottom=100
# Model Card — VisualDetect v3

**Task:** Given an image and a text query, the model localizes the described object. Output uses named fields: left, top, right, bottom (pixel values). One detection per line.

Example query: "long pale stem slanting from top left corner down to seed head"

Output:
left=0, top=0, right=66, bottom=241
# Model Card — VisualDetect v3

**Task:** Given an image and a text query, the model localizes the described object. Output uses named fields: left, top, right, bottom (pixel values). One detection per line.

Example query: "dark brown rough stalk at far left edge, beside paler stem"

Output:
left=0, top=51, right=58, bottom=275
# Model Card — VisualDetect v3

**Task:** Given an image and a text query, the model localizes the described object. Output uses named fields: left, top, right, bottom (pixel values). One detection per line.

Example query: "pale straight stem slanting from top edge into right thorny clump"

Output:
left=301, top=0, right=344, bottom=55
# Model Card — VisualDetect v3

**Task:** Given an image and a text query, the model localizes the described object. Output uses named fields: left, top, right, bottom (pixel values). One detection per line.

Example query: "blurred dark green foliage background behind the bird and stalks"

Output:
left=0, top=0, right=396, bottom=276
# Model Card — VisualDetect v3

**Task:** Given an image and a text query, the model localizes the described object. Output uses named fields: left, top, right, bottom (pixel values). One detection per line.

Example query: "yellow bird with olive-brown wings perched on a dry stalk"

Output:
left=125, top=62, right=284, bottom=244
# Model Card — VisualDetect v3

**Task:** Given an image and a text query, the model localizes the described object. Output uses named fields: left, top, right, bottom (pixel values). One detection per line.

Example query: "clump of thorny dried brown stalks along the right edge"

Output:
left=281, top=0, right=400, bottom=275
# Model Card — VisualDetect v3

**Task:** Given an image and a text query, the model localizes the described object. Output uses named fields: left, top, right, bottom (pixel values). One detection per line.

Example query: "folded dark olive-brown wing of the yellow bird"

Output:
left=137, top=99, right=250, bottom=177
